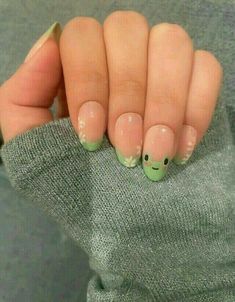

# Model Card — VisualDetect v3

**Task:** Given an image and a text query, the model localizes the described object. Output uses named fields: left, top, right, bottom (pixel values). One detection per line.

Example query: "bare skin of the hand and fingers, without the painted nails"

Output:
left=0, top=11, right=223, bottom=182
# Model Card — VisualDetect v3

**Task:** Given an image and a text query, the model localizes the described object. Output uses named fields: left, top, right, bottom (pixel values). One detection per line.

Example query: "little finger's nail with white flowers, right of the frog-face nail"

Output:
left=173, top=125, right=197, bottom=165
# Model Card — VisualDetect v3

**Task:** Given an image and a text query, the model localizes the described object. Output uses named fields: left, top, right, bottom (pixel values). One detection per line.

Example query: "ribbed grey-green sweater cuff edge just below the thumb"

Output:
left=0, top=118, right=98, bottom=178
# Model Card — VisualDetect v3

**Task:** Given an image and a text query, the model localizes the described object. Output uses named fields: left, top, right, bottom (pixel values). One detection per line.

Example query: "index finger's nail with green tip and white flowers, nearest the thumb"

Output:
left=78, top=101, right=105, bottom=151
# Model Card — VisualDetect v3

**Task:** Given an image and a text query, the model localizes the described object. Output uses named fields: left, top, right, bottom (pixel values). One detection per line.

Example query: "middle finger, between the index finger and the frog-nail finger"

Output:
left=104, top=11, right=149, bottom=167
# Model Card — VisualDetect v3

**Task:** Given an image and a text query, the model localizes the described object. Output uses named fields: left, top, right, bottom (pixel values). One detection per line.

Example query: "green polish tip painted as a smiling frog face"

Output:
left=143, top=154, right=169, bottom=181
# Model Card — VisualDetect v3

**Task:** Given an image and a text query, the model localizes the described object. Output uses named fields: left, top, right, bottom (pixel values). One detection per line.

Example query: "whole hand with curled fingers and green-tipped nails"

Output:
left=0, top=11, right=222, bottom=181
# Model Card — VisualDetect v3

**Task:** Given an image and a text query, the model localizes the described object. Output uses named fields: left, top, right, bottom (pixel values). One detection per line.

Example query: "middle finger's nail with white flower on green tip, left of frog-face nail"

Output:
left=114, top=113, right=143, bottom=167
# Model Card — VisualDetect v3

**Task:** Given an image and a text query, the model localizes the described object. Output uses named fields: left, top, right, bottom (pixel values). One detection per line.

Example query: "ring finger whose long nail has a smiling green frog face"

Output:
left=143, top=23, right=193, bottom=181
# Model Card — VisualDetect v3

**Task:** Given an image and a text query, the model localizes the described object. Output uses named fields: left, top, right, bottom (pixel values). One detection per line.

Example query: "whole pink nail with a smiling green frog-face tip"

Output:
left=142, top=125, right=175, bottom=181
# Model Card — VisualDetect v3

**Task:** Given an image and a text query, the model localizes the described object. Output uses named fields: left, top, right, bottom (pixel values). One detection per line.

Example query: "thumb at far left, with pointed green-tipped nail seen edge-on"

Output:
left=0, top=23, right=61, bottom=142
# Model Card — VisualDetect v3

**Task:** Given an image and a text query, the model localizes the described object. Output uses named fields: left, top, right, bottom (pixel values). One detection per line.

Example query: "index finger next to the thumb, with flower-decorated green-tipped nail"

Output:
left=60, top=17, right=108, bottom=151
